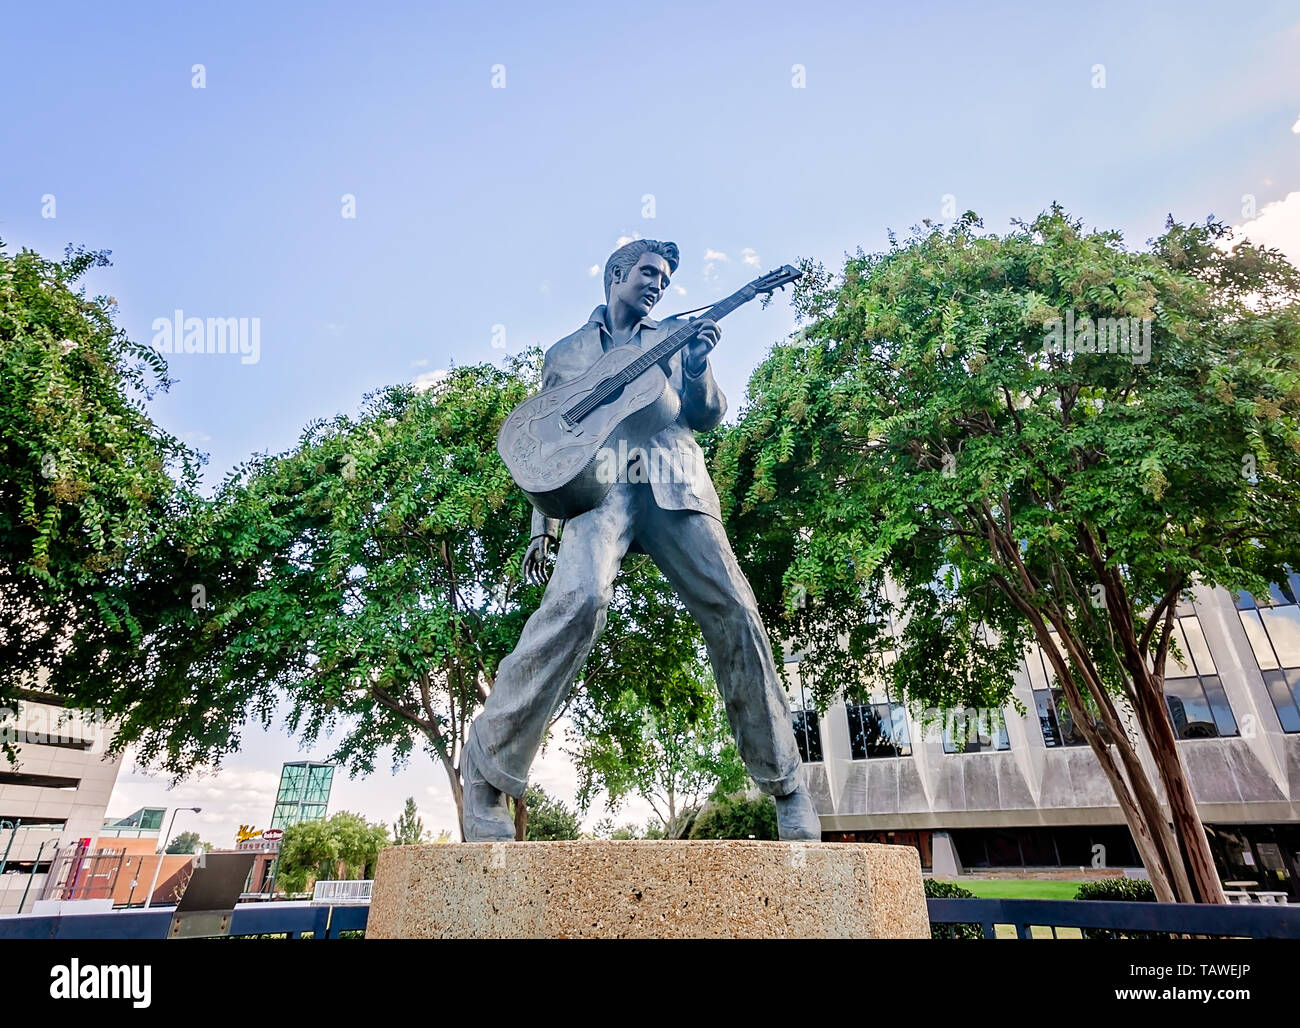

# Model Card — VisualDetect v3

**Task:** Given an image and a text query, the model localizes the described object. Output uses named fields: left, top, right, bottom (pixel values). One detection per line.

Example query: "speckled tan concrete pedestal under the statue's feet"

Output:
left=365, top=841, right=930, bottom=938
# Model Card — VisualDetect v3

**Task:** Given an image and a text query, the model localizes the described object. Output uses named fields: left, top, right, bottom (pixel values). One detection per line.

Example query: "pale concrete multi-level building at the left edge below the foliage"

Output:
left=0, top=700, right=121, bottom=914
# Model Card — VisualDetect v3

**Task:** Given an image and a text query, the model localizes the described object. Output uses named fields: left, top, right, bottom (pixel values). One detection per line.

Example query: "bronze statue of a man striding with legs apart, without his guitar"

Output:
left=460, top=239, right=822, bottom=842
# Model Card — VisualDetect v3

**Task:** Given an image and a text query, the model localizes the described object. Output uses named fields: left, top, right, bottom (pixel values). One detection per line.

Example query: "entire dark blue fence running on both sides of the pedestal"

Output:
left=0, top=899, right=1300, bottom=940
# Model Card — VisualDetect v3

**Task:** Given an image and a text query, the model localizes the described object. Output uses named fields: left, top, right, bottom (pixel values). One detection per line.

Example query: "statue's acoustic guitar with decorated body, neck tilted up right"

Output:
left=497, top=264, right=802, bottom=519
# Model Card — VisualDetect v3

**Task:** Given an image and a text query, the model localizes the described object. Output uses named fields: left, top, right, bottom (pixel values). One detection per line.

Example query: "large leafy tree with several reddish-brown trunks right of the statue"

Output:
left=718, top=208, right=1300, bottom=902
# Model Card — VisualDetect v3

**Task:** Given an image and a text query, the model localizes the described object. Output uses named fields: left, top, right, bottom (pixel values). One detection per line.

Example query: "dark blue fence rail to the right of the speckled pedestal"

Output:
left=926, top=899, right=1300, bottom=938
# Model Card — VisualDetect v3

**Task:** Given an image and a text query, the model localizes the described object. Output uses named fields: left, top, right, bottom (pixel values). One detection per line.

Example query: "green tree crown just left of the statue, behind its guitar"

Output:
left=73, top=365, right=538, bottom=790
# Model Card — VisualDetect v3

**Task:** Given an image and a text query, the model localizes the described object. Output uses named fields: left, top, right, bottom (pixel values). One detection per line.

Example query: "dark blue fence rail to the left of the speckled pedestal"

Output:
left=0, top=903, right=371, bottom=940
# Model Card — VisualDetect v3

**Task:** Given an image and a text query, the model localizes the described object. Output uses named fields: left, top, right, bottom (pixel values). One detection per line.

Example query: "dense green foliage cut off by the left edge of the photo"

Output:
left=0, top=244, right=202, bottom=732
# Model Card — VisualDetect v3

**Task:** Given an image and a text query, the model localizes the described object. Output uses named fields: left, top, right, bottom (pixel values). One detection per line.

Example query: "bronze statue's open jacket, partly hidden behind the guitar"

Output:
left=533, top=304, right=727, bottom=534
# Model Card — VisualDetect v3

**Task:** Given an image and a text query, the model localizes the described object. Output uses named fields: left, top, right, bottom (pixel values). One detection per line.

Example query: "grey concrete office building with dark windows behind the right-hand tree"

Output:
left=787, top=574, right=1300, bottom=899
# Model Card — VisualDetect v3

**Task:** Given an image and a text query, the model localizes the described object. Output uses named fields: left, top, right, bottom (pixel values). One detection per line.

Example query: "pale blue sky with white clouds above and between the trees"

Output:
left=0, top=3, right=1300, bottom=841
